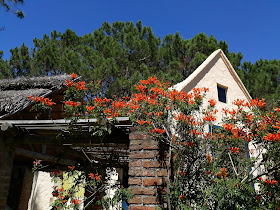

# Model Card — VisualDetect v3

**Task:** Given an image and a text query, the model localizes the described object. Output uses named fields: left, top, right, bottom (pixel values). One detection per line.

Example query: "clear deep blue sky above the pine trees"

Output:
left=0, top=0, right=280, bottom=62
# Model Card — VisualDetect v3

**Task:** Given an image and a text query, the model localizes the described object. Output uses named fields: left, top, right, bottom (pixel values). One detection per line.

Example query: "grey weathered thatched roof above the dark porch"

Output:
left=0, top=75, right=70, bottom=119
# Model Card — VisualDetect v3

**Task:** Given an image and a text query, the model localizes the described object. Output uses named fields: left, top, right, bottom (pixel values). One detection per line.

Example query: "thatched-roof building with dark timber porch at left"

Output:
left=0, top=75, right=130, bottom=210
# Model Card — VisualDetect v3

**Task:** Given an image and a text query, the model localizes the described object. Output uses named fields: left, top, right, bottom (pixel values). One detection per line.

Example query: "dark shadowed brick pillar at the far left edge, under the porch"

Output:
left=0, top=137, right=14, bottom=209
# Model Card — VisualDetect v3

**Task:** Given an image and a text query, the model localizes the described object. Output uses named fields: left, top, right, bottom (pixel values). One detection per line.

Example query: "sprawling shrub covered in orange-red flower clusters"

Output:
left=31, top=74, right=280, bottom=209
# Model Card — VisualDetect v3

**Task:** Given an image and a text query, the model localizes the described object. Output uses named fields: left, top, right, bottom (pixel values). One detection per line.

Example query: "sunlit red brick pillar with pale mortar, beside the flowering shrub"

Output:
left=128, top=128, right=167, bottom=210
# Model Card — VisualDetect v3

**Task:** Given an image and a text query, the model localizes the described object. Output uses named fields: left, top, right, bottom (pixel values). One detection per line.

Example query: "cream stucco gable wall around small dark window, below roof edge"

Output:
left=182, top=55, right=248, bottom=124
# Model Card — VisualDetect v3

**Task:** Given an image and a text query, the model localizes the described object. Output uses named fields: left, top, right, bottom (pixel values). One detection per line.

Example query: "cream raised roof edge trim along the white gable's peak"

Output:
left=174, top=49, right=252, bottom=101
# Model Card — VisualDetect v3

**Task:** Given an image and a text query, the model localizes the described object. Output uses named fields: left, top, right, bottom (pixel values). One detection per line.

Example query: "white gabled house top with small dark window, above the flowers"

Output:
left=174, top=49, right=252, bottom=123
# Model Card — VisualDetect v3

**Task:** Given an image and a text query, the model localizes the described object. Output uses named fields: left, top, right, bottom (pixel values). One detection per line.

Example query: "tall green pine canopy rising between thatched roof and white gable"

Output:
left=3, top=21, right=242, bottom=97
